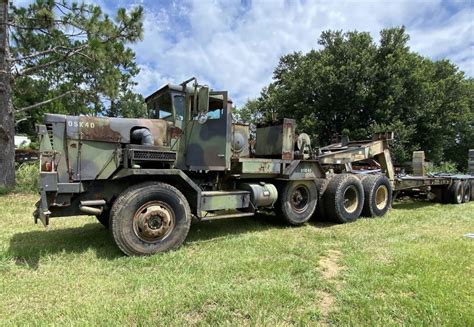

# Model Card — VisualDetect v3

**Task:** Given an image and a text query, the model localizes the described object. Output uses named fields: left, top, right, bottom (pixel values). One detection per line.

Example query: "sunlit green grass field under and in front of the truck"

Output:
left=0, top=194, right=474, bottom=326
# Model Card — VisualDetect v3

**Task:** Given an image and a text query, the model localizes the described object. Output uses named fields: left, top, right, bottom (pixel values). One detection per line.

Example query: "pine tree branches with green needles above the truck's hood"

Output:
left=0, top=0, right=143, bottom=186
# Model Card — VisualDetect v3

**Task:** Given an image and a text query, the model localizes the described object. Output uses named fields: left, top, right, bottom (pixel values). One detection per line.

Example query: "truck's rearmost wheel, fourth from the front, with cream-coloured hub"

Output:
left=362, top=175, right=392, bottom=217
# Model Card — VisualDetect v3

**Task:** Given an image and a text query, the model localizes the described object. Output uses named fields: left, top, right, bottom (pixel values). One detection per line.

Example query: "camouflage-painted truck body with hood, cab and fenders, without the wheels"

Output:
left=38, top=79, right=325, bottom=223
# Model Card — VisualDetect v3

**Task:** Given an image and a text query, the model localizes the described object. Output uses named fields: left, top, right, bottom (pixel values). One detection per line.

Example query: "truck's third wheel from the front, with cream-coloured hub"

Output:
left=323, top=174, right=364, bottom=223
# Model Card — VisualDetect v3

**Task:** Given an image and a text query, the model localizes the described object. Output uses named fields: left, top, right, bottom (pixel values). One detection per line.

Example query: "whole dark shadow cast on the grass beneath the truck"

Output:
left=8, top=210, right=335, bottom=269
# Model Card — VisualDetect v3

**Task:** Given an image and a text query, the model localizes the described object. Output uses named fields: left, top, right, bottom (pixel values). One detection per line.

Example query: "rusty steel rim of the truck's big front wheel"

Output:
left=132, top=201, right=176, bottom=243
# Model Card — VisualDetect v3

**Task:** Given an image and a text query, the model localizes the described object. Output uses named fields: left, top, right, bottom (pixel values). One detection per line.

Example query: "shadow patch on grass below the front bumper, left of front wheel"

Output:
left=8, top=223, right=122, bottom=269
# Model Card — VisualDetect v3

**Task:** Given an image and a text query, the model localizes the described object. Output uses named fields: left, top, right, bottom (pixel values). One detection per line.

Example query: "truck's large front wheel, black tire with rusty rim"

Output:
left=110, top=182, right=191, bottom=256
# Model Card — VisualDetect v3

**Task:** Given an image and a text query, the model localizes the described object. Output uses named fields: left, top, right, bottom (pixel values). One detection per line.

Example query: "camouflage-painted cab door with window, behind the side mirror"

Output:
left=185, top=92, right=232, bottom=170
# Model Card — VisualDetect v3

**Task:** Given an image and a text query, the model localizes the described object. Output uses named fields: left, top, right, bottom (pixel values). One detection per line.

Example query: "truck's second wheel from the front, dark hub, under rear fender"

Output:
left=276, top=181, right=318, bottom=226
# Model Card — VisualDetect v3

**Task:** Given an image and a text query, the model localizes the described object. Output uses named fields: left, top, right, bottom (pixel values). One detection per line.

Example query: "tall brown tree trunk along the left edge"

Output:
left=0, top=0, right=15, bottom=188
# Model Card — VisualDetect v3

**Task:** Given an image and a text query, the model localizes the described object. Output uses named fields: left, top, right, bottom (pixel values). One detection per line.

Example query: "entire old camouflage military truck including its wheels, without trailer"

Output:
left=35, top=78, right=466, bottom=255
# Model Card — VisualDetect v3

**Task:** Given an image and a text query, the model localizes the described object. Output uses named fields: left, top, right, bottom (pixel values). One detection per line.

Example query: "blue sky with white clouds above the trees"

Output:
left=14, top=0, right=474, bottom=107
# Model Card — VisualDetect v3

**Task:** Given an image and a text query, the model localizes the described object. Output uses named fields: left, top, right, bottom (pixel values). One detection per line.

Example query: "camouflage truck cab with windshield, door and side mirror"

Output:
left=145, top=84, right=232, bottom=171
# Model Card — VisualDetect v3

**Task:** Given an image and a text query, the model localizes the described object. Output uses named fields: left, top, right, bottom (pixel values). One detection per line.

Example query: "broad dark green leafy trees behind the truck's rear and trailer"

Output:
left=239, top=27, right=474, bottom=170
